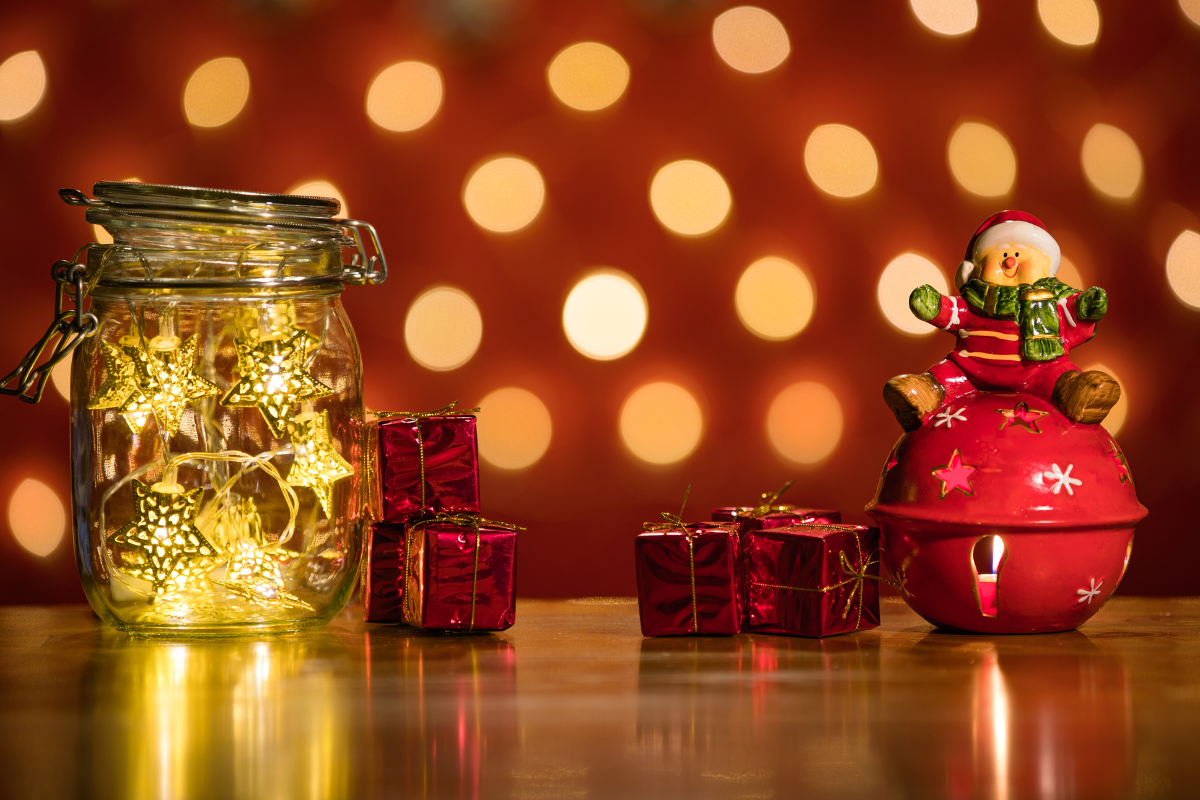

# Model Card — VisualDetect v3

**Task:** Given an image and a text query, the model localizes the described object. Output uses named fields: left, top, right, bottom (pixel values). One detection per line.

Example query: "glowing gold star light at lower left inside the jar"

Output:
left=108, top=479, right=218, bottom=595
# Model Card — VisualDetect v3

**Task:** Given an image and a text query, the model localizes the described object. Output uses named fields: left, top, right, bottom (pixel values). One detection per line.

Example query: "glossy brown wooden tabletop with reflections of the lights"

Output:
left=0, top=599, right=1200, bottom=799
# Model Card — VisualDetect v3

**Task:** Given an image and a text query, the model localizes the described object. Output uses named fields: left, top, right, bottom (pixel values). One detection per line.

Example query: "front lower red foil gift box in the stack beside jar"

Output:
left=403, top=522, right=517, bottom=631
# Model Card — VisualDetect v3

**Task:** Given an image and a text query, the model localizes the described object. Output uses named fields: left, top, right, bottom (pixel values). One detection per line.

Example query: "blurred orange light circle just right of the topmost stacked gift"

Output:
left=478, top=386, right=551, bottom=469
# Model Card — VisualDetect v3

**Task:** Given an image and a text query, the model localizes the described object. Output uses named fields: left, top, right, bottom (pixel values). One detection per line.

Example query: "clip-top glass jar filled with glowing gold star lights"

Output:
left=18, top=182, right=386, bottom=634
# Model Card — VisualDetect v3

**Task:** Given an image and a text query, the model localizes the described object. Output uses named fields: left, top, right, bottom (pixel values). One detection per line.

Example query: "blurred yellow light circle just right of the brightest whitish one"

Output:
left=734, top=255, right=816, bottom=341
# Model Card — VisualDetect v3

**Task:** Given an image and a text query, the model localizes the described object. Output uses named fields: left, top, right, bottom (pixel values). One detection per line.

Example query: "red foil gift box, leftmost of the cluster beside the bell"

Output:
left=634, top=522, right=742, bottom=636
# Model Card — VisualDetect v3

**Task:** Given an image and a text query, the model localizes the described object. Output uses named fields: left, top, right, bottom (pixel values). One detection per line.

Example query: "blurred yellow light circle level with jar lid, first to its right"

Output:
left=462, top=156, right=546, bottom=234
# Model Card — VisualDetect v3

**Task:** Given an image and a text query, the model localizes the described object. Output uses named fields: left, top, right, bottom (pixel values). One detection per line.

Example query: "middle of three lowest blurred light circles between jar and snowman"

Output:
left=620, top=383, right=704, bottom=464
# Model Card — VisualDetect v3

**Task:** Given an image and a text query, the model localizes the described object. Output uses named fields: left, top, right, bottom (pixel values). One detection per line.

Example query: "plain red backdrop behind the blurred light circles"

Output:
left=0, top=0, right=1200, bottom=603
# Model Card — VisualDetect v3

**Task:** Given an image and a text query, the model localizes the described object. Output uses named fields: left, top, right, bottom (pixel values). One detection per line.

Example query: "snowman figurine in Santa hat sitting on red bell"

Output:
left=883, top=211, right=1121, bottom=431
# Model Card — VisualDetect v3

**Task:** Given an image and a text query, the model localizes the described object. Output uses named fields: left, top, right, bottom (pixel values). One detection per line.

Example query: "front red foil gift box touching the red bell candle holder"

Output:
left=742, top=524, right=880, bottom=637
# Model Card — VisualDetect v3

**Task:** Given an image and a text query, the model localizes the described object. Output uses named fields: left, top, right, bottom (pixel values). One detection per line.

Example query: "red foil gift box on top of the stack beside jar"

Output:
left=377, top=414, right=479, bottom=523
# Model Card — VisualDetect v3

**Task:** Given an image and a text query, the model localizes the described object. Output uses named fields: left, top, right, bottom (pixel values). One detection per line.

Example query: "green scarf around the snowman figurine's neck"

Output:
left=960, top=278, right=1075, bottom=361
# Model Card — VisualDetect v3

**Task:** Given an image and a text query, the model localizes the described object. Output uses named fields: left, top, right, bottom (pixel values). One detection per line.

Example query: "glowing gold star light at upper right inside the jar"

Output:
left=221, top=331, right=334, bottom=439
